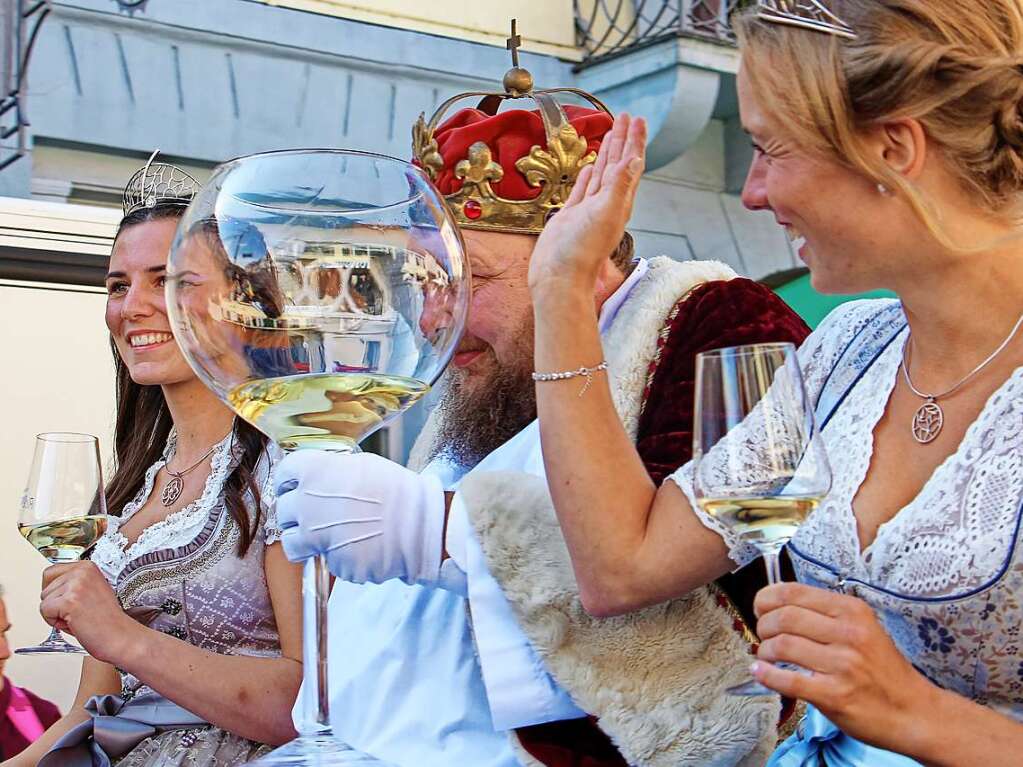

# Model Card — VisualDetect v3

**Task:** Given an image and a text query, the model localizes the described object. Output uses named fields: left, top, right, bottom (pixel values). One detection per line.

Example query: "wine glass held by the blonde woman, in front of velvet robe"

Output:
left=693, top=344, right=832, bottom=695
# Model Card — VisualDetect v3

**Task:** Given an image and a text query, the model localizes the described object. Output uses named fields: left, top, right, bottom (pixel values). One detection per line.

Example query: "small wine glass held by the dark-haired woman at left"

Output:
left=14, top=432, right=107, bottom=655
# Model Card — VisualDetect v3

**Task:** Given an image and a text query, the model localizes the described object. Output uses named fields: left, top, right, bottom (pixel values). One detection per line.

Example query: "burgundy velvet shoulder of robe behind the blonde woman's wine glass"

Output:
left=636, top=278, right=810, bottom=485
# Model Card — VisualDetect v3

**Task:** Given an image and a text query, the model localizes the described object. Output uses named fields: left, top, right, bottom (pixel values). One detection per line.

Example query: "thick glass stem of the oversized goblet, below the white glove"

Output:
left=299, top=554, right=332, bottom=737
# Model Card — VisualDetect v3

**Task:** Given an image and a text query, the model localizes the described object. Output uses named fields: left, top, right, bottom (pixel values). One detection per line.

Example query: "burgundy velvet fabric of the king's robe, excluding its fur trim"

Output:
left=517, top=278, right=809, bottom=767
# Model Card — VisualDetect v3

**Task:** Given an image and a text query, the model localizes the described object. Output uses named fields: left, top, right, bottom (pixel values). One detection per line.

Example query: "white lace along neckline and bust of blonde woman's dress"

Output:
left=796, top=353, right=1023, bottom=598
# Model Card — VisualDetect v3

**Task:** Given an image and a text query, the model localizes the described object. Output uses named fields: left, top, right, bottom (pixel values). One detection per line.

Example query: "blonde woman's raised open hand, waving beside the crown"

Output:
left=529, top=112, right=647, bottom=292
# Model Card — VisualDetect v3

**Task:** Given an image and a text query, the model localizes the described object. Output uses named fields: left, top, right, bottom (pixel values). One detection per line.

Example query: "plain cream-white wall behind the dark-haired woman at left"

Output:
left=0, top=280, right=114, bottom=712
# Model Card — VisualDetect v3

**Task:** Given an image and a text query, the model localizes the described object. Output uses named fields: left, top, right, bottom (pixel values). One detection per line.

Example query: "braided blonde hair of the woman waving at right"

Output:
left=735, top=0, right=1023, bottom=251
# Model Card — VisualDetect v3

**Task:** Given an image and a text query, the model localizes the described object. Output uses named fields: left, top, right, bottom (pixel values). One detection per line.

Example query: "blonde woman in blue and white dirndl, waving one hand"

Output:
left=530, top=0, right=1023, bottom=767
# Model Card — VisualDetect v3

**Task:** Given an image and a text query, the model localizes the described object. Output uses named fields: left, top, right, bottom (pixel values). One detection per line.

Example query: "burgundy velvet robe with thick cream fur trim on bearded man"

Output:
left=410, top=258, right=807, bottom=767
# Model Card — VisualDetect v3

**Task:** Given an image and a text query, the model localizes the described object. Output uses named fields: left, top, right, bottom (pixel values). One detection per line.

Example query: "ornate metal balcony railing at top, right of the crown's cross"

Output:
left=574, top=0, right=750, bottom=66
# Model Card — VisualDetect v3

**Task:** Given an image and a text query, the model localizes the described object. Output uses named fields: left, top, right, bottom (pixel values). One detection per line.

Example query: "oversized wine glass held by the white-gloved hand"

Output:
left=167, top=149, right=470, bottom=765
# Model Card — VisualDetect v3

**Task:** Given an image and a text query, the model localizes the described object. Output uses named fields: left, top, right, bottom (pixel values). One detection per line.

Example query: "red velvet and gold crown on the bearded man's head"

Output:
left=412, top=48, right=614, bottom=234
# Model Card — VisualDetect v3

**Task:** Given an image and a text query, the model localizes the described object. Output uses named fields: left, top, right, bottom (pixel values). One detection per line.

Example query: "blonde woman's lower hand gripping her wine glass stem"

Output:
left=753, top=583, right=939, bottom=752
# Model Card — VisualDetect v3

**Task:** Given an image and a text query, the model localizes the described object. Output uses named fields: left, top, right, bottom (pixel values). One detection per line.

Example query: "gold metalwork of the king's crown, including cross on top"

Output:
left=412, top=20, right=613, bottom=234
